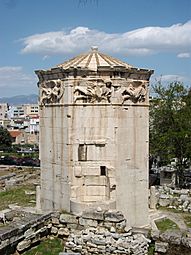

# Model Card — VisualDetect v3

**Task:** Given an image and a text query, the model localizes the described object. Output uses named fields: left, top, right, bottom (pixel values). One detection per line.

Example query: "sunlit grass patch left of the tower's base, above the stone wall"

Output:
left=0, top=185, right=36, bottom=210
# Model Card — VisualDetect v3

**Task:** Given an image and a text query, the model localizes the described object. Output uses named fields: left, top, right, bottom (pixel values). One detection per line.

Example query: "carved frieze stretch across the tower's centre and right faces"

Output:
left=74, top=79, right=147, bottom=104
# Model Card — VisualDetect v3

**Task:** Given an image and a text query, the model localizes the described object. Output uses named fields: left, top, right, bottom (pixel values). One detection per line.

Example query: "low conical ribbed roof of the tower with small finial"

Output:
left=57, top=46, right=133, bottom=71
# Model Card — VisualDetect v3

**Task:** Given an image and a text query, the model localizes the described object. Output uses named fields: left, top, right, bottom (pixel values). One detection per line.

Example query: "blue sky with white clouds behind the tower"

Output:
left=0, top=0, right=191, bottom=97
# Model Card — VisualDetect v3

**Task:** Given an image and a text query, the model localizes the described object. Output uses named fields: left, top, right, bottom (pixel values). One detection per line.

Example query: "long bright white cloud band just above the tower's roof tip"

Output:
left=21, top=21, right=191, bottom=57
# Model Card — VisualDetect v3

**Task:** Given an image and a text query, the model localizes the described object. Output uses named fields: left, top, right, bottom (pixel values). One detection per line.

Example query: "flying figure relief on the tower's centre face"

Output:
left=74, top=80, right=112, bottom=103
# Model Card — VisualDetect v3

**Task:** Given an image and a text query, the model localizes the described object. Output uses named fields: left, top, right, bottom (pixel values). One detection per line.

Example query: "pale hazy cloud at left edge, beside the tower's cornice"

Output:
left=0, top=66, right=37, bottom=96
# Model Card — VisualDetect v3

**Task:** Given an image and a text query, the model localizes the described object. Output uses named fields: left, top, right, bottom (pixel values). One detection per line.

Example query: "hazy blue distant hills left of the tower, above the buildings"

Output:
left=0, top=94, right=38, bottom=105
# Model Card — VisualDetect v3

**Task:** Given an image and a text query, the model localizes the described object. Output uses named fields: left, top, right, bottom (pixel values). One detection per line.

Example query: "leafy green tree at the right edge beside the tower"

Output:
left=150, top=81, right=191, bottom=186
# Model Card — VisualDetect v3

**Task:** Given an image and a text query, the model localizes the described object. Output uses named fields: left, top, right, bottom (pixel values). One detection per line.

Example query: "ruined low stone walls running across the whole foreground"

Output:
left=0, top=208, right=191, bottom=255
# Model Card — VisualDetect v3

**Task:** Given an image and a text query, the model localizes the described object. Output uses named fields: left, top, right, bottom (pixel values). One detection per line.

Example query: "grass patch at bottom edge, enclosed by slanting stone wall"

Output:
left=23, top=238, right=64, bottom=255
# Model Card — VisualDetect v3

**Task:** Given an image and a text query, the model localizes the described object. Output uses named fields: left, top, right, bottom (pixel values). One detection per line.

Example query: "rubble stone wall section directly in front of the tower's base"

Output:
left=62, top=210, right=150, bottom=255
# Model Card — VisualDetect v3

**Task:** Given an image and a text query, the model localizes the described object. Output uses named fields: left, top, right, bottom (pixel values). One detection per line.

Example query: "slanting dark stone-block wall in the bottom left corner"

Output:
left=0, top=211, right=51, bottom=255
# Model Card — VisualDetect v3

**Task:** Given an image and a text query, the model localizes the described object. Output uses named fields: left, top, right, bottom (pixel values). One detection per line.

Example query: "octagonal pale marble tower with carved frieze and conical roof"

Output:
left=36, top=47, right=153, bottom=227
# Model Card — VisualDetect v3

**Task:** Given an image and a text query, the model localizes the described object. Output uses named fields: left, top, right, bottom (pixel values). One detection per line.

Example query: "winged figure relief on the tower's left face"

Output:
left=40, top=80, right=64, bottom=105
